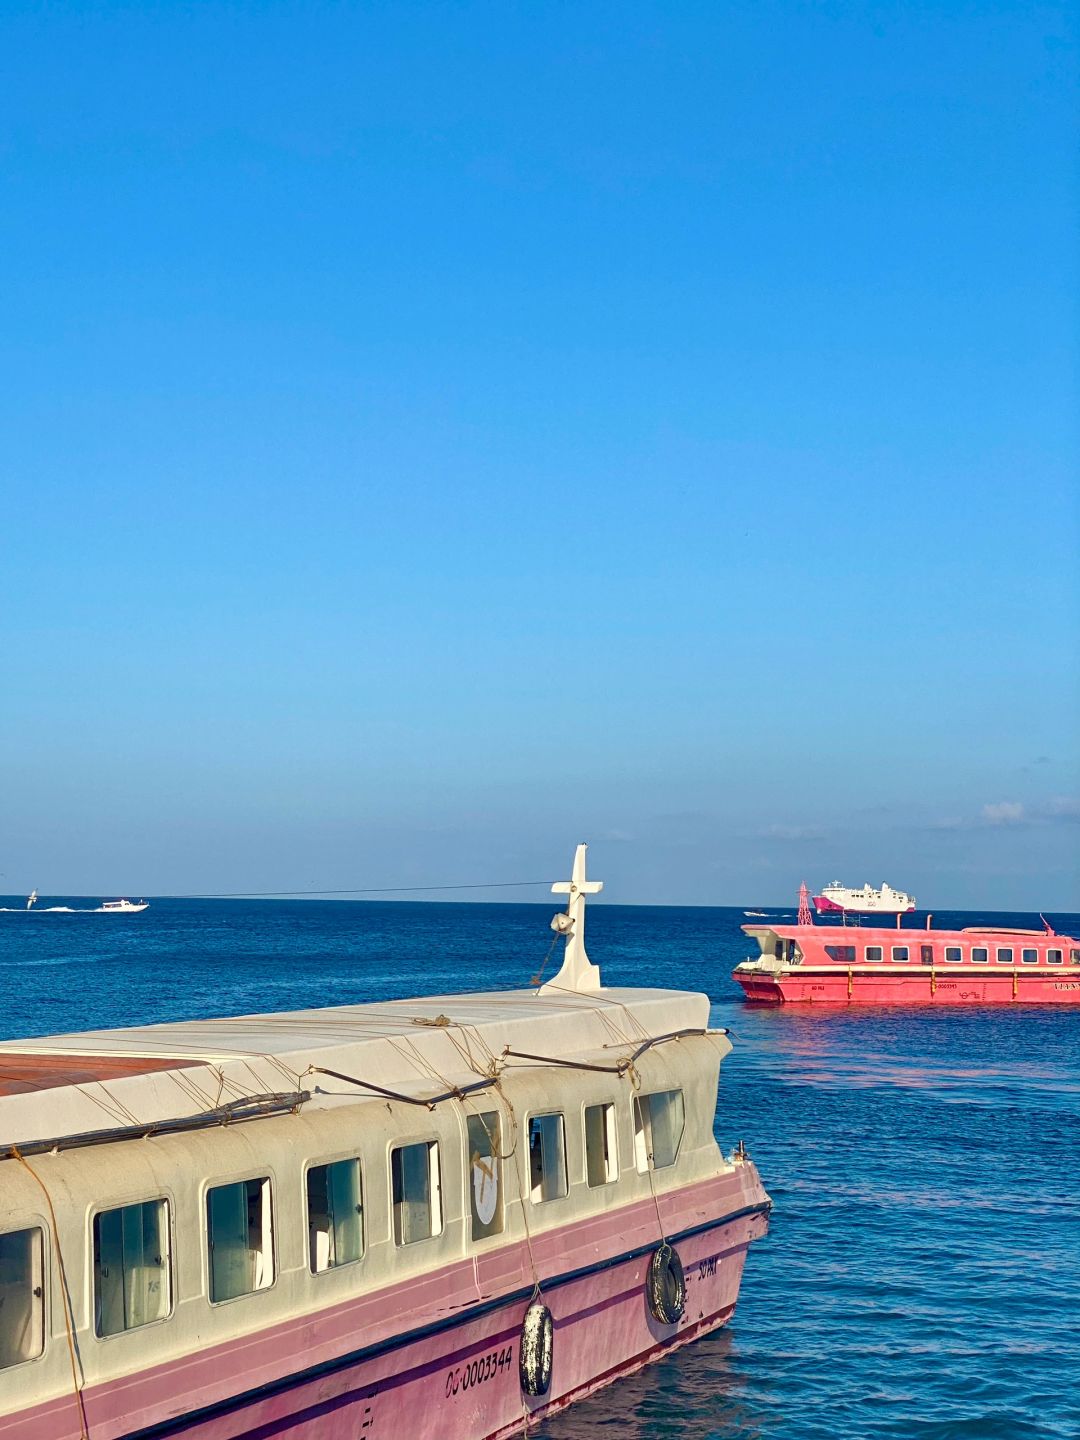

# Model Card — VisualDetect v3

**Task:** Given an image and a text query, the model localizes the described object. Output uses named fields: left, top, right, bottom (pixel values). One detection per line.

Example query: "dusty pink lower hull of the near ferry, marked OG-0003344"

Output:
left=0, top=1162, right=769, bottom=1440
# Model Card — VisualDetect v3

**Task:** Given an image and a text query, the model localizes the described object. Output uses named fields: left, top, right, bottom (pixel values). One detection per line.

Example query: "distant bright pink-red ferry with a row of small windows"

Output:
left=732, top=906, right=1080, bottom=1005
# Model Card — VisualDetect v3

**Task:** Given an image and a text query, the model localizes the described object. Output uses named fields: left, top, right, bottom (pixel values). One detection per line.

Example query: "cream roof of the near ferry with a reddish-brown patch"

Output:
left=0, top=986, right=708, bottom=1155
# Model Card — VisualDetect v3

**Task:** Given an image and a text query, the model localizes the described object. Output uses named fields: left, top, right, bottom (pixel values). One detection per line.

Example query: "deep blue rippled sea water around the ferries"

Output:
left=0, top=900, right=1080, bottom=1440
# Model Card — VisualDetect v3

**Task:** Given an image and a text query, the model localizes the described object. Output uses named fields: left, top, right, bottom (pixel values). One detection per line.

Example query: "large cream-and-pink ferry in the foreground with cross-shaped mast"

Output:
left=0, top=845, right=770, bottom=1440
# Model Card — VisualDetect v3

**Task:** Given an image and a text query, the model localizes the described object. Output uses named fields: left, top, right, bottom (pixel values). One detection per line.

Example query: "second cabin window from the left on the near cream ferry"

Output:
left=94, top=1200, right=171, bottom=1335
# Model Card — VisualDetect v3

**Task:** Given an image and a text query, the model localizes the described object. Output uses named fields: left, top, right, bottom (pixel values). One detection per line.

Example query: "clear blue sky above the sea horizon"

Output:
left=0, top=0, right=1080, bottom=909
